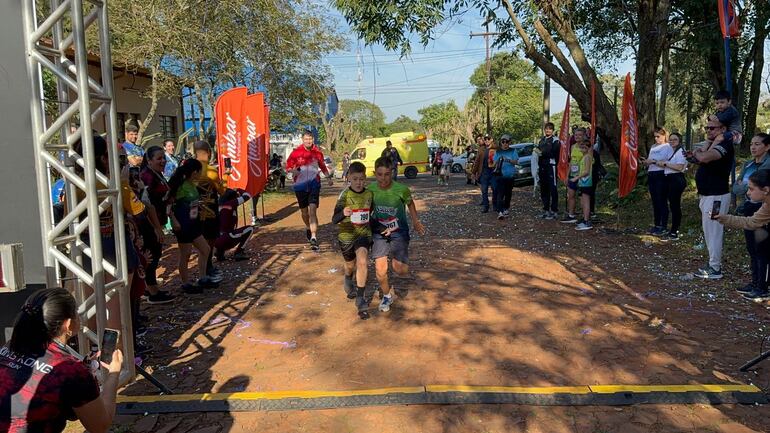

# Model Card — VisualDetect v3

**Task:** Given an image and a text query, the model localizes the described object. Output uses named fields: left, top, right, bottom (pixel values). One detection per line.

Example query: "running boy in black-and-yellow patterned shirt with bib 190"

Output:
left=332, top=162, right=373, bottom=320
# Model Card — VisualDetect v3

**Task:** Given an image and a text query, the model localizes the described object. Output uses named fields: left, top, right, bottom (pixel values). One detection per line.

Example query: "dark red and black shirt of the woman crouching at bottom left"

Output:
left=0, top=342, right=99, bottom=433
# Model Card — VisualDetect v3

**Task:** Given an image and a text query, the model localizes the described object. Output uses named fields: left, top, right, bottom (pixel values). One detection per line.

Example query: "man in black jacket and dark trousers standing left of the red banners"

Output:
left=537, top=122, right=561, bottom=220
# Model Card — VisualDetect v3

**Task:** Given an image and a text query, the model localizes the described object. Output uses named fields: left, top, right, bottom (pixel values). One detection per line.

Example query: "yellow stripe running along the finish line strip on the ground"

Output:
left=117, top=385, right=762, bottom=403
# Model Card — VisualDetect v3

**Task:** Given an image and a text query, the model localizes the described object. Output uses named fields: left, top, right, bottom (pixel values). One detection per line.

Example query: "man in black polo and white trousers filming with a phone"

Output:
left=688, top=116, right=735, bottom=280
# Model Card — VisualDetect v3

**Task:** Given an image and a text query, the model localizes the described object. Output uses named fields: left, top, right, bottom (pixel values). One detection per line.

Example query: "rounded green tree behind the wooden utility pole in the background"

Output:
left=470, top=52, right=543, bottom=141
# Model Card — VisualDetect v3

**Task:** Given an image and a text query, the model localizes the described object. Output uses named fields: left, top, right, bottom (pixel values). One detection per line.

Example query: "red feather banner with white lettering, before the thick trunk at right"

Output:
left=618, top=74, right=639, bottom=198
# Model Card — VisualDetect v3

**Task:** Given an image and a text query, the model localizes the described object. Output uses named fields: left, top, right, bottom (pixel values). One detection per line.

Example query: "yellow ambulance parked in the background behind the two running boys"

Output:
left=350, top=132, right=430, bottom=179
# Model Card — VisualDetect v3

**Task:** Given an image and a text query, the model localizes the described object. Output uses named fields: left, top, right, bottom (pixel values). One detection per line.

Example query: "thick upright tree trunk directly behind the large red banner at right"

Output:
left=634, top=0, right=671, bottom=155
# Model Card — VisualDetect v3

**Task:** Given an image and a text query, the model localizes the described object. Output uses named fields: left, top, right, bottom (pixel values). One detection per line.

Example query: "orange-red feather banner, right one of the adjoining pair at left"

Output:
left=243, top=93, right=267, bottom=196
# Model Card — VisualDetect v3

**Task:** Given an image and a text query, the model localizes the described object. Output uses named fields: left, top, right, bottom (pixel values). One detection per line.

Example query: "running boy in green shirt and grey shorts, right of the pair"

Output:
left=368, top=158, right=425, bottom=312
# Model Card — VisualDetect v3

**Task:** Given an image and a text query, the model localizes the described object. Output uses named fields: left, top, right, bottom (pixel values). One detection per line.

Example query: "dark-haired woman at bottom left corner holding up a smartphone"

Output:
left=0, top=288, right=123, bottom=433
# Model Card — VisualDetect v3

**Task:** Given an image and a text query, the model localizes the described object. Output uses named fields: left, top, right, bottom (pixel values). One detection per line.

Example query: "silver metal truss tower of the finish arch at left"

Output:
left=23, top=0, right=135, bottom=383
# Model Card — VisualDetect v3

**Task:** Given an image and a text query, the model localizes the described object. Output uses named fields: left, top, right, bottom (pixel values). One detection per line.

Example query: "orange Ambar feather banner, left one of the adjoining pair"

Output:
left=214, top=87, right=248, bottom=189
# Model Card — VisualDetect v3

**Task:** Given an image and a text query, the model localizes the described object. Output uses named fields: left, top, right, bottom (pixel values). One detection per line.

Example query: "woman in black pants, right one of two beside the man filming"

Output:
left=656, top=132, right=687, bottom=241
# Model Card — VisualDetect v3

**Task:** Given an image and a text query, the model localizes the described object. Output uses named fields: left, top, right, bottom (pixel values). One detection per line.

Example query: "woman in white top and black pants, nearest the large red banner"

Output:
left=642, top=128, right=673, bottom=236
